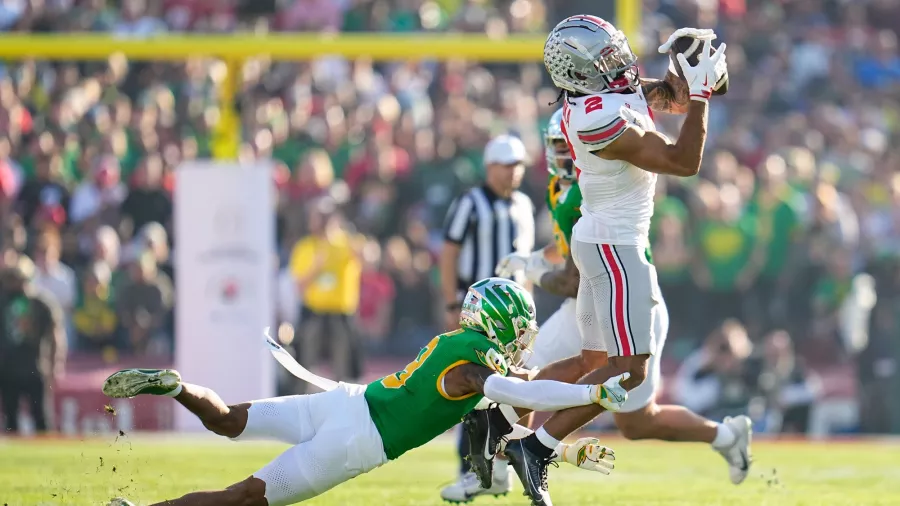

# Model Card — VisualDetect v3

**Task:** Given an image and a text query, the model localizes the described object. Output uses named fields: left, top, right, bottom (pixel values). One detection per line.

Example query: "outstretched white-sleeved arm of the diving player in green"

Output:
left=444, top=362, right=625, bottom=411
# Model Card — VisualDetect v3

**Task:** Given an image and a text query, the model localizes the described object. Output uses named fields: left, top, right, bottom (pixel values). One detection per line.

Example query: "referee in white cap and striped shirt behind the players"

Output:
left=440, top=135, right=535, bottom=494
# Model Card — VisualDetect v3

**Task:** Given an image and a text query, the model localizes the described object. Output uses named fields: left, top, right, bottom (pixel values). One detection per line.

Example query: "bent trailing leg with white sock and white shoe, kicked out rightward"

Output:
left=614, top=303, right=752, bottom=484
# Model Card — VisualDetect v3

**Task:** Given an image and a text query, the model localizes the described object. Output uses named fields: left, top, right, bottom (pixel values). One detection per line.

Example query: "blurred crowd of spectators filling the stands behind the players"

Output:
left=0, top=0, right=900, bottom=432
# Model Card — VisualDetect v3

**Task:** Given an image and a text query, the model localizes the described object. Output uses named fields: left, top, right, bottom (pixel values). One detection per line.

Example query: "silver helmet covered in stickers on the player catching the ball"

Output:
left=544, top=15, right=640, bottom=95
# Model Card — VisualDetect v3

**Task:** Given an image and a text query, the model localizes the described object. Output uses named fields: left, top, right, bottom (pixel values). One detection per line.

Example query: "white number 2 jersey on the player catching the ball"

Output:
left=562, top=90, right=656, bottom=246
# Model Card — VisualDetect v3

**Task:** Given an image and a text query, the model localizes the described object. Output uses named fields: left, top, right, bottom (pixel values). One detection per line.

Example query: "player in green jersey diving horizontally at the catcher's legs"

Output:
left=96, top=278, right=627, bottom=506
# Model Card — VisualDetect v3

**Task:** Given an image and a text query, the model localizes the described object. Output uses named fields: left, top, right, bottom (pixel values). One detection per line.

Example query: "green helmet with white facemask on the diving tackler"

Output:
left=459, top=278, right=538, bottom=366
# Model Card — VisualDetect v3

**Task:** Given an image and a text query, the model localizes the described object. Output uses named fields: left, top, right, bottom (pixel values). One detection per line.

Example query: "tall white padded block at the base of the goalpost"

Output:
left=175, top=161, right=277, bottom=430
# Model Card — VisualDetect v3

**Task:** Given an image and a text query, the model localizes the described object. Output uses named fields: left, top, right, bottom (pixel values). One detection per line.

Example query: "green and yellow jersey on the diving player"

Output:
left=365, top=329, right=508, bottom=460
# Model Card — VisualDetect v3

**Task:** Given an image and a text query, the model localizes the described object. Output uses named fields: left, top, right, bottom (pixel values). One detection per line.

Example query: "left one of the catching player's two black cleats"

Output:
left=463, top=405, right=512, bottom=488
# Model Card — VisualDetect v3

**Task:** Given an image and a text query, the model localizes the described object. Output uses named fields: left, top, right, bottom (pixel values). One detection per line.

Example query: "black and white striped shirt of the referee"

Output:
left=444, top=186, right=534, bottom=301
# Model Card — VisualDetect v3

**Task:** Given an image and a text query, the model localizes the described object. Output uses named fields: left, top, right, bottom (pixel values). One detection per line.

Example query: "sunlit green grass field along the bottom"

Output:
left=0, top=436, right=900, bottom=506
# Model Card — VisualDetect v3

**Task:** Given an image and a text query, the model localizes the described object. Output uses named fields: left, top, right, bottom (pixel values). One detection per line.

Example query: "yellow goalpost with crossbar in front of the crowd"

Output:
left=0, top=0, right=641, bottom=160
